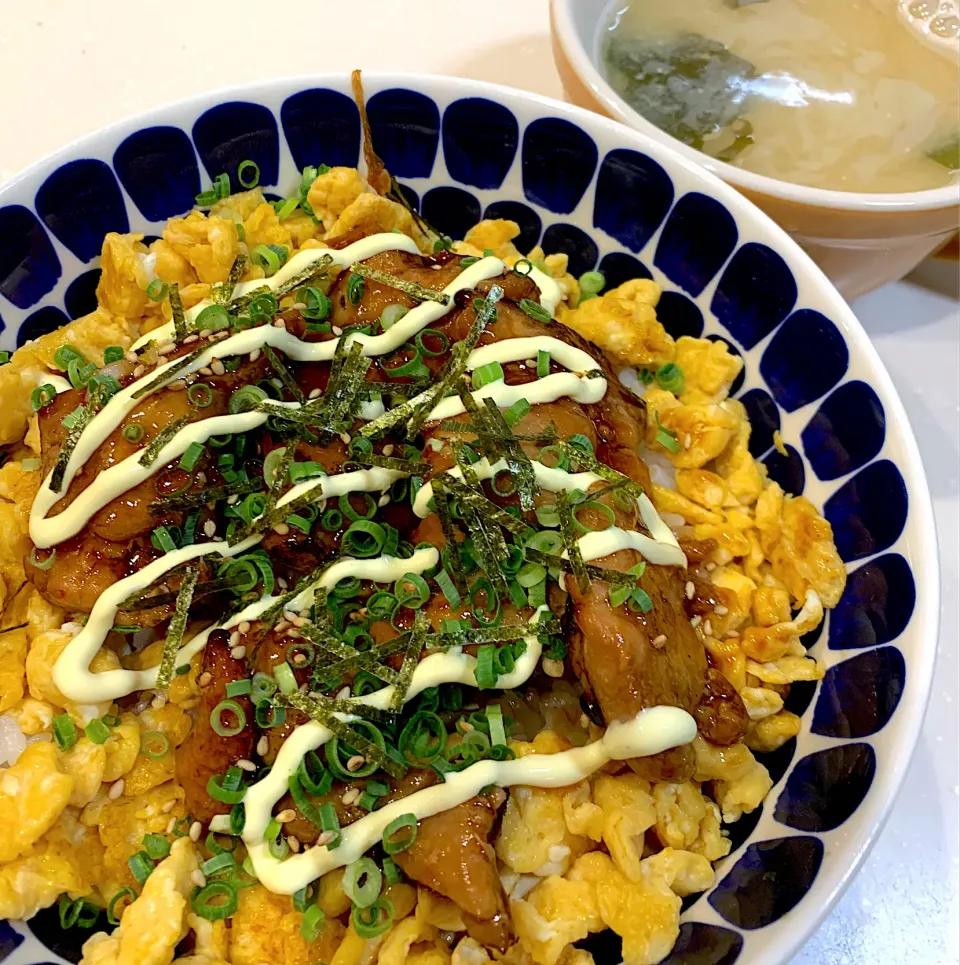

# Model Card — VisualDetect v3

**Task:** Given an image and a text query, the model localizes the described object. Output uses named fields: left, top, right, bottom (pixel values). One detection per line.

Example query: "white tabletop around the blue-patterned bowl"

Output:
left=0, top=0, right=960, bottom=965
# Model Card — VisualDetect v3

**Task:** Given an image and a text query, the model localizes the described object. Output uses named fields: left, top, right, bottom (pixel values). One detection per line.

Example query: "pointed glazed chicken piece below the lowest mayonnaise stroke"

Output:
left=394, top=796, right=512, bottom=950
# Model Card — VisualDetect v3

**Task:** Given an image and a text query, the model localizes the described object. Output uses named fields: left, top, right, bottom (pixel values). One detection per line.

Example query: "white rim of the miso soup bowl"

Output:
left=550, top=0, right=960, bottom=214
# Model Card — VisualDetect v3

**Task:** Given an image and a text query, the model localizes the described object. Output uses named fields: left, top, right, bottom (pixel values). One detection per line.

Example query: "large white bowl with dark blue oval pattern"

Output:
left=0, top=75, right=939, bottom=965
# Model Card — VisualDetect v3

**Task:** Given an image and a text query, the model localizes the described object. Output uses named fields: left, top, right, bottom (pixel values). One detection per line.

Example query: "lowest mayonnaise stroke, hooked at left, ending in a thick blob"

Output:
left=243, top=696, right=697, bottom=895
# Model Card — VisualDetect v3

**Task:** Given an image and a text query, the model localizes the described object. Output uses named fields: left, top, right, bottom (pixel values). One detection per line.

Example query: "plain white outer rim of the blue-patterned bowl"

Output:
left=0, top=71, right=940, bottom=965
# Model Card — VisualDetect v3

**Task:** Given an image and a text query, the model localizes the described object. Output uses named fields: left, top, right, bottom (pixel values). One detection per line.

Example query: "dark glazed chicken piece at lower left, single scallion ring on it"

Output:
left=176, top=630, right=256, bottom=824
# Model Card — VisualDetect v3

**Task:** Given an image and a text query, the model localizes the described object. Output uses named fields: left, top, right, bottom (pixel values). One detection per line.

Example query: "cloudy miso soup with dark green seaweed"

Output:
left=600, top=0, right=960, bottom=192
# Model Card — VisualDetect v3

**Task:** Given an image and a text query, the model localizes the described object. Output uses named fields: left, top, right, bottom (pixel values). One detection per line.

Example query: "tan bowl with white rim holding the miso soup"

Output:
left=550, top=0, right=960, bottom=300
